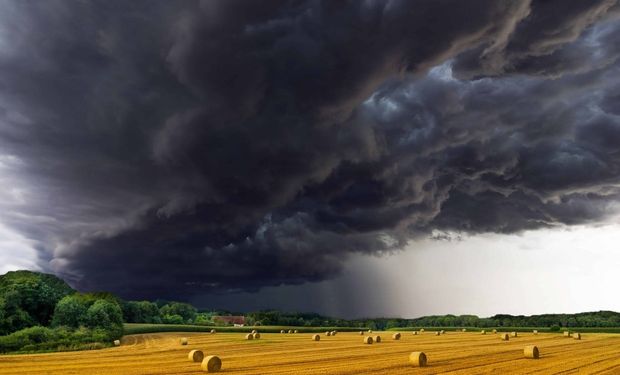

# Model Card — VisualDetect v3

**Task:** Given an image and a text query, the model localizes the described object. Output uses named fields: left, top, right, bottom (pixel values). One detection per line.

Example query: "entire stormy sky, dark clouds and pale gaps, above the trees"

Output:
left=0, top=0, right=620, bottom=317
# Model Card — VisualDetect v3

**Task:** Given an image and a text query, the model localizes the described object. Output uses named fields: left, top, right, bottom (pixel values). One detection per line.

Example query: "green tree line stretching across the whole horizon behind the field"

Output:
left=0, top=271, right=620, bottom=352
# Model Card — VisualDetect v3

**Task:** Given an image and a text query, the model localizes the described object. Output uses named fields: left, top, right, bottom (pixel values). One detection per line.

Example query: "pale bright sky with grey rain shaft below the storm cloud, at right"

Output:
left=195, top=224, right=620, bottom=318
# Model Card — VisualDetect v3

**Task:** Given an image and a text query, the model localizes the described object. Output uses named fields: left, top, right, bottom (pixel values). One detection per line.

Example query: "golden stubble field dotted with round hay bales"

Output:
left=0, top=331, right=620, bottom=375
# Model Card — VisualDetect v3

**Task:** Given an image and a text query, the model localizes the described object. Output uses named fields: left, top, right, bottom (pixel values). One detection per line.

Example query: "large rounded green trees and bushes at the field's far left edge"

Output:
left=0, top=271, right=123, bottom=352
